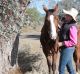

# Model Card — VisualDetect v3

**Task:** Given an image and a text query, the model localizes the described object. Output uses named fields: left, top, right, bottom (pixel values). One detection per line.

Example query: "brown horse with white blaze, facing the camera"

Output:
left=40, top=4, right=59, bottom=74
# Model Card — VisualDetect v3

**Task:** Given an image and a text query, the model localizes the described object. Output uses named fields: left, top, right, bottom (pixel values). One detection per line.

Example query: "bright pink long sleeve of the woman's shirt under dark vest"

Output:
left=63, top=26, right=77, bottom=47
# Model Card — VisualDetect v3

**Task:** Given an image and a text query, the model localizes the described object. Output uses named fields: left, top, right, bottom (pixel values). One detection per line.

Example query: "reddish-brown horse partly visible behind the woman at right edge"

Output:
left=73, top=27, right=80, bottom=74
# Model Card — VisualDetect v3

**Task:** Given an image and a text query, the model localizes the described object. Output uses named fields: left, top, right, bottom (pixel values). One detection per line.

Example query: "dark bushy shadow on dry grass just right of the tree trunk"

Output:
left=18, top=52, right=41, bottom=74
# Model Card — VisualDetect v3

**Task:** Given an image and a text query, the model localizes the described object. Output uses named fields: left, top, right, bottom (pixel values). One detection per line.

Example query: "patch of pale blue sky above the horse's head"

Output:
left=29, top=0, right=60, bottom=14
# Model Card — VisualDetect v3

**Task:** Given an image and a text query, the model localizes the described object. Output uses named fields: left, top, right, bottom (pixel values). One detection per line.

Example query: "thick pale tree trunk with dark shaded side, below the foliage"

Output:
left=0, top=34, right=22, bottom=74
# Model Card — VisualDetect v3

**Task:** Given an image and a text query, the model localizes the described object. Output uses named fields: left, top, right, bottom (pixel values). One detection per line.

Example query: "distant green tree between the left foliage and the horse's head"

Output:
left=26, top=8, right=43, bottom=29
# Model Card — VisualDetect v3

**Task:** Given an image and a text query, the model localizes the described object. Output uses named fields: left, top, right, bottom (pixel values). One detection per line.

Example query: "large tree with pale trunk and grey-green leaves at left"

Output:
left=0, top=0, right=29, bottom=74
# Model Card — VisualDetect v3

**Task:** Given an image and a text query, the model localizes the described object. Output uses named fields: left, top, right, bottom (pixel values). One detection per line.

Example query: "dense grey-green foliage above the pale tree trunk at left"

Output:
left=0, top=0, right=29, bottom=39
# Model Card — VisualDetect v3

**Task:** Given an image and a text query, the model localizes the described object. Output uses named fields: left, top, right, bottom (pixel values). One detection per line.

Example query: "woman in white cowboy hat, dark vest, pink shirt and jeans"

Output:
left=58, top=8, right=78, bottom=74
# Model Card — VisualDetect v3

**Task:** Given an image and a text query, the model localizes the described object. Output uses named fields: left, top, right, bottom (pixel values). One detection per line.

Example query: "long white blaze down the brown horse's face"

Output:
left=50, top=15, right=57, bottom=40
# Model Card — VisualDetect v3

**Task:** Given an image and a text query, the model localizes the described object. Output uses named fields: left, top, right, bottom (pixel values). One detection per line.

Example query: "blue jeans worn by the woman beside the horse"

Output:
left=59, top=47, right=75, bottom=74
